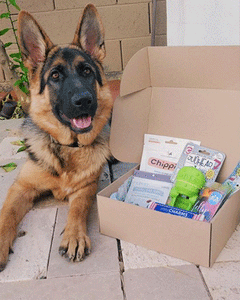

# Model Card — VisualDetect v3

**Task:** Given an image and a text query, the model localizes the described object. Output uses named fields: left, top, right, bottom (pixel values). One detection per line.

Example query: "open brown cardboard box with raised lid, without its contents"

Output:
left=97, top=46, right=240, bottom=267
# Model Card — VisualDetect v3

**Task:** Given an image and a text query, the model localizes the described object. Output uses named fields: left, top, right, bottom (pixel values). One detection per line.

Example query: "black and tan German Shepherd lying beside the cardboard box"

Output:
left=0, top=4, right=112, bottom=271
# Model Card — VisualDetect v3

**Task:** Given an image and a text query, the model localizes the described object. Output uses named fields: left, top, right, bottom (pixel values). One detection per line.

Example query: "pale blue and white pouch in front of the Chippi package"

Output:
left=125, top=170, right=172, bottom=208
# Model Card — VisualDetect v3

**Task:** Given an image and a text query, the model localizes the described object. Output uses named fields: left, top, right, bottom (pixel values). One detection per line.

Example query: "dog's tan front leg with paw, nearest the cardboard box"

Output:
left=59, top=182, right=97, bottom=261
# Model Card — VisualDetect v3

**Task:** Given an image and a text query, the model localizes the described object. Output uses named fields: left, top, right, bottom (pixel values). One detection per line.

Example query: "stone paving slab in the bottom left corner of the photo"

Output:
left=0, top=272, right=123, bottom=300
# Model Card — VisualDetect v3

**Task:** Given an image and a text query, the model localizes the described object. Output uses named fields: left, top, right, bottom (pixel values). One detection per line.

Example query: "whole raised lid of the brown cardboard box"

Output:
left=110, top=46, right=240, bottom=181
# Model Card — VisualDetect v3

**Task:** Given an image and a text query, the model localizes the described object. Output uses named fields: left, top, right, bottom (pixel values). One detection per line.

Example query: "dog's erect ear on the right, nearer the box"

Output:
left=72, top=4, right=106, bottom=62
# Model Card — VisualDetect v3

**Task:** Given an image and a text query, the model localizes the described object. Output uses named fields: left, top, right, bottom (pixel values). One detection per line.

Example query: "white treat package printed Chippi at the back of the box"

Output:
left=140, top=134, right=200, bottom=175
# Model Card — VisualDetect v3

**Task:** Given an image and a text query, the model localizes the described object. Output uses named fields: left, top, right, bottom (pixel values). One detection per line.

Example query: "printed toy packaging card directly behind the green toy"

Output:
left=171, top=142, right=225, bottom=186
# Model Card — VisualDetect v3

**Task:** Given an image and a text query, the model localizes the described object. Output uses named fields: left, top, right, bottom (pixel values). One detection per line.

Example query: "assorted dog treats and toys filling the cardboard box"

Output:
left=111, top=134, right=240, bottom=222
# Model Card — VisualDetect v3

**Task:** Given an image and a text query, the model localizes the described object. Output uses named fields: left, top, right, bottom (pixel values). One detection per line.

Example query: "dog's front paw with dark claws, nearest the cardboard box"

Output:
left=59, top=231, right=91, bottom=261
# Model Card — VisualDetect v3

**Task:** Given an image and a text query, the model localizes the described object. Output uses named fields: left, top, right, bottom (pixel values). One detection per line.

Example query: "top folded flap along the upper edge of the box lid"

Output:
left=120, top=46, right=240, bottom=97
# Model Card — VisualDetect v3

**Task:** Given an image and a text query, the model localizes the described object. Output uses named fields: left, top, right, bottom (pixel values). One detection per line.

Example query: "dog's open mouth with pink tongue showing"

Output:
left=59, top=111, right=92, bottom=133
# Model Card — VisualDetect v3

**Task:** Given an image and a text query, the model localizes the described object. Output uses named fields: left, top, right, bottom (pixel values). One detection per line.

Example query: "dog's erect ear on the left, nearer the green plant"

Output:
left=18, top=11, right=53, bottom=68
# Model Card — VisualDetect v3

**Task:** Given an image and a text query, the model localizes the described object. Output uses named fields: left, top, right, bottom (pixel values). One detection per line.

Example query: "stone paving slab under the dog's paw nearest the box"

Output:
left=48, top=207, right=119, bottom=278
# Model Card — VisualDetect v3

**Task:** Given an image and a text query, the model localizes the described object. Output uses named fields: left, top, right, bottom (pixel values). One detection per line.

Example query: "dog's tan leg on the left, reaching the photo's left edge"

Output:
left=0, top=162, right=56, bottom=272
